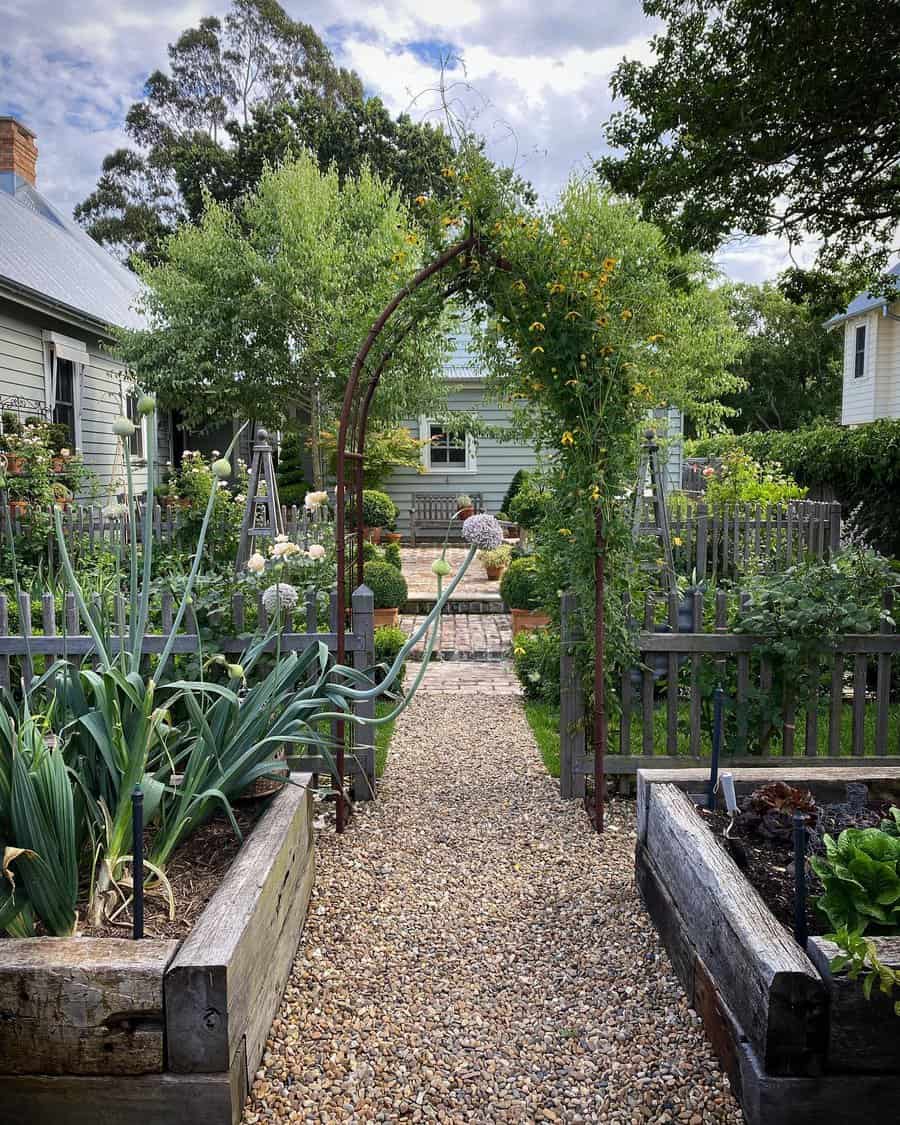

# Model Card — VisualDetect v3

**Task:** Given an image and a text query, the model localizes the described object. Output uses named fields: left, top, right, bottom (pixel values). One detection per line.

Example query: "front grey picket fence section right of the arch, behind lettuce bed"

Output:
left=559, top=591, right=900, bottom=797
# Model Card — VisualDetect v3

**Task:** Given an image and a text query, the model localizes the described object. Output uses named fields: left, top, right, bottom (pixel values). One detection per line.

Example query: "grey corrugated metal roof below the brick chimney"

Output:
left=0, top=185, right=144, bottom=327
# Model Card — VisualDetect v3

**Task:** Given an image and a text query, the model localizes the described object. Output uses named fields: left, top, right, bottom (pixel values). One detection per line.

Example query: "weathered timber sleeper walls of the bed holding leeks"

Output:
left=0, top=774, right=315, bottom=1125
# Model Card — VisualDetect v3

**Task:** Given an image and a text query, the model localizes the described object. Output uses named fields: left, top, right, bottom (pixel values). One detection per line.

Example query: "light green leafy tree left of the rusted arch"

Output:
left=119, top=153, right=454, bottom=479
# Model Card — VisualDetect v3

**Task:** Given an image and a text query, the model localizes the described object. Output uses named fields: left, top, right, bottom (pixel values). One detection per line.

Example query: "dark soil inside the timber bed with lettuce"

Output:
left=699, top=802, right=888, bottom=935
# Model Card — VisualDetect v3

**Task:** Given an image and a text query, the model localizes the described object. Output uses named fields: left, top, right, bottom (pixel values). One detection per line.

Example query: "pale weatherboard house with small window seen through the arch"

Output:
left=385, top=336, right=683, bottom=537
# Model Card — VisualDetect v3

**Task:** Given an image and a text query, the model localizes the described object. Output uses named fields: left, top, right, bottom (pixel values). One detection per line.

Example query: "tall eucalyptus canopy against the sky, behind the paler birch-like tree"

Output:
left=75, top=0, right=451, bottom=260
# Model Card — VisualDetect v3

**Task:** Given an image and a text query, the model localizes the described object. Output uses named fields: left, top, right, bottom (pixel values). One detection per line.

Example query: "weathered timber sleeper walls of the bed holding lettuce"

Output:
left=636, top=765, right=900, bottom=1125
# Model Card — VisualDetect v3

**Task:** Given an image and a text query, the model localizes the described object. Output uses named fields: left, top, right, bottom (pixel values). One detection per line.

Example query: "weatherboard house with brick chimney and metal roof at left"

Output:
left=0, top=117, right=173, bottom=502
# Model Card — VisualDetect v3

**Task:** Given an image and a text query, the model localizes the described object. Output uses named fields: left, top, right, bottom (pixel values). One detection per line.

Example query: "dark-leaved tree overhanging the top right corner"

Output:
left=599, top=0, right=900, bottom=279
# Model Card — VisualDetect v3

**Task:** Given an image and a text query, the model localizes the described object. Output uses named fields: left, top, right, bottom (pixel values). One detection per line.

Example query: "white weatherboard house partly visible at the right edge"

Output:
left=825, top=262, right=900, bottom=425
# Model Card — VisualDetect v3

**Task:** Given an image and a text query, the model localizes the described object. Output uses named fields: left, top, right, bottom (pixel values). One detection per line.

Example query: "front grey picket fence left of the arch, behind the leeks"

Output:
left=0, top=586, right=375, bottom=800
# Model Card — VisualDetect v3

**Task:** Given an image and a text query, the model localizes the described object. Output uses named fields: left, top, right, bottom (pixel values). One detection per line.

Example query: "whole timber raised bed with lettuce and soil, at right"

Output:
left=636, top=765, right=900, bottom=1125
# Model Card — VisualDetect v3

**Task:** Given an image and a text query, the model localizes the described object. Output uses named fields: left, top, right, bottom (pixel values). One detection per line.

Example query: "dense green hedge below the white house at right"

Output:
left=691, top=419, right=900, bottom=557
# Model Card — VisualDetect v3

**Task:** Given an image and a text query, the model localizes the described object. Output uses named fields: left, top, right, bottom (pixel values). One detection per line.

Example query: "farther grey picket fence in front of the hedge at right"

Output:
left=669, top=501, right=842, bottom=578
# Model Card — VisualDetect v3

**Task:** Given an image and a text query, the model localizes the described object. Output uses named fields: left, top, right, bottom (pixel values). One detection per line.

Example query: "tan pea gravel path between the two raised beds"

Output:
left=244, top=694, right=743, bottom=1125
